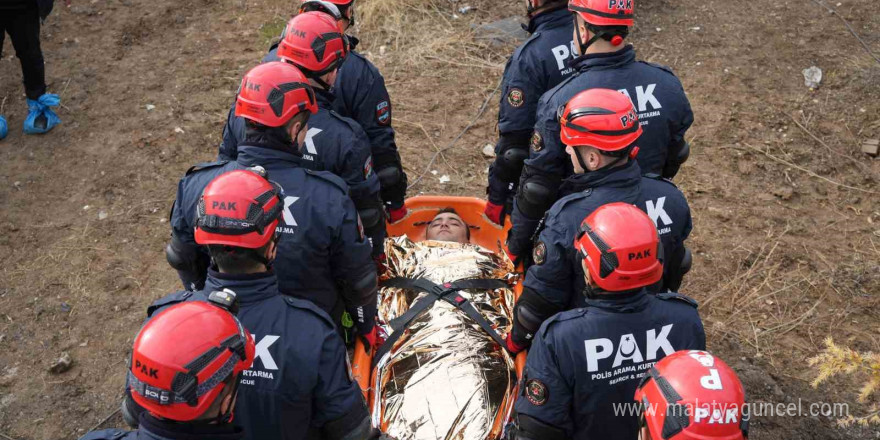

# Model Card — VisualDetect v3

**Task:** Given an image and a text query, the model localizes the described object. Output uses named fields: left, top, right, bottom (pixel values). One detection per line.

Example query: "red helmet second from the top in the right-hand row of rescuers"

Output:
left=559, top=89, right=642, bottom=152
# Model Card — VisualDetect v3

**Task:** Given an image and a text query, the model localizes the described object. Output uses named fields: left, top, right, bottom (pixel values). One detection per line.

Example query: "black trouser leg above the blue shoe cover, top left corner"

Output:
left=6, top=8, right=46, bottom=100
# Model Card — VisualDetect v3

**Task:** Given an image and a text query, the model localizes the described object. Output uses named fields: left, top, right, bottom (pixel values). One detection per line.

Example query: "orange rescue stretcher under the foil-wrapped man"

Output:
left=352, top=196, right=526, bottom=440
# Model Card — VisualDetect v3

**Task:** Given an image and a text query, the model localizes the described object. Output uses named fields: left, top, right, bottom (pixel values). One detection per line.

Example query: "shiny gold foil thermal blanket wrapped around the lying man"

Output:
left=372, top=236, right=516, bottom=440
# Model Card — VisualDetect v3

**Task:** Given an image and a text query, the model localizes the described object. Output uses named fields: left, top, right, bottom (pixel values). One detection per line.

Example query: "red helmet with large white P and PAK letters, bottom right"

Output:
left=635, top=350, right=749, bottom=440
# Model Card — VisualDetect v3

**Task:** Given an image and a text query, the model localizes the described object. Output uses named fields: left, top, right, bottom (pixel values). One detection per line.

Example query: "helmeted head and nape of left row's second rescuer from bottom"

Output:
left=195, top=167, right=284, bottom=273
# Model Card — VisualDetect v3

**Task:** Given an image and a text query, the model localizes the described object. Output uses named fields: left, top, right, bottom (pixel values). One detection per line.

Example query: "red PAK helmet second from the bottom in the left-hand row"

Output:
left=195, top=170, right=284, bottom=249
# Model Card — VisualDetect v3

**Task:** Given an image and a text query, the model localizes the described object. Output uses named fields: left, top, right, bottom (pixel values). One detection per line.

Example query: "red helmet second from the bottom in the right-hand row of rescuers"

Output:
left=574, top=203, right=663, bottom=292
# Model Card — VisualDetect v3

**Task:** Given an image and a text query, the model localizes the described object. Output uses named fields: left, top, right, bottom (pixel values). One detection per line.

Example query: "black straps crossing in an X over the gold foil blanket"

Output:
left=373, top=277, right=509, bottom=367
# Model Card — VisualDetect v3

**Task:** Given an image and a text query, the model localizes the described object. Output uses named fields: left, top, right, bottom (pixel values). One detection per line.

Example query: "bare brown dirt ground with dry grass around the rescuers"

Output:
left=0, top=0, right=880, bottom=439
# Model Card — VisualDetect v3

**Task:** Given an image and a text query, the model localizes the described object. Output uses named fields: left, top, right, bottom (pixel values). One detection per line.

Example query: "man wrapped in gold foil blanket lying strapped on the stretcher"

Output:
left=366, top=207, right=517, bottom=440
